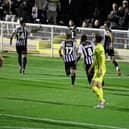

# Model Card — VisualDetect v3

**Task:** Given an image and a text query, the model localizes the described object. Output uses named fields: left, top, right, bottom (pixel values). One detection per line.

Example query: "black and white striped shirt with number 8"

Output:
left=78, top=41, right=94, bottom=65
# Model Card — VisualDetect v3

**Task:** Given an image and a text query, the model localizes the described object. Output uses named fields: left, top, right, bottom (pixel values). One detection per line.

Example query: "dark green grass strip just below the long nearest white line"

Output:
left=0, top=114, right=100, bottom=129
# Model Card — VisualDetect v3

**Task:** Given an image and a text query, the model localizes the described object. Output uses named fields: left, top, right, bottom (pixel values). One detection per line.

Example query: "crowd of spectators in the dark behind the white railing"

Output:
left=0, top=0, right=129, bottom=30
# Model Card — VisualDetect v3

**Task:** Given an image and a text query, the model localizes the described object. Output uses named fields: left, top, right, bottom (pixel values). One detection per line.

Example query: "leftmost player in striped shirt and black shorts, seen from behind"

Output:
left=10, top=18, right=28, bottom=74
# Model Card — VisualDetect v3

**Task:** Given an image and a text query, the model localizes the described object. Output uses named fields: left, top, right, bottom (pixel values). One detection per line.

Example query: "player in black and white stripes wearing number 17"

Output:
left=59, top=33, right=78, bottom=87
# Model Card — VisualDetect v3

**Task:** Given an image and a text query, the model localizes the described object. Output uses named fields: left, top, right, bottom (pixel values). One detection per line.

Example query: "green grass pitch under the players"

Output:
left=0, top=54, right=129, bottom=129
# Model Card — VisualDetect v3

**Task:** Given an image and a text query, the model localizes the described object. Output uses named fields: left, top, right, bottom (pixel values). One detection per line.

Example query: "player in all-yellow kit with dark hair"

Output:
left=88, top=35, right=106, bottom=108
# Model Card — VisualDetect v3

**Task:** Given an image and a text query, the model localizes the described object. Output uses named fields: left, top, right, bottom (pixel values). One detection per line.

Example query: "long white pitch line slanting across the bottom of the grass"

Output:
left=0, top=114, right=127, bottom=129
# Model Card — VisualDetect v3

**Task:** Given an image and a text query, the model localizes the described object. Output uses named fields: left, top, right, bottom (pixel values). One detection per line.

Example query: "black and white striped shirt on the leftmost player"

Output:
left=14, top=26, right=28, bottom=46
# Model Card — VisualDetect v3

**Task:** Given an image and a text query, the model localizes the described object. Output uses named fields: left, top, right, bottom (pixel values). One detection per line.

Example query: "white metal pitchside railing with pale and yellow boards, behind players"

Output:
left=0, top=21, right=129, bottom=57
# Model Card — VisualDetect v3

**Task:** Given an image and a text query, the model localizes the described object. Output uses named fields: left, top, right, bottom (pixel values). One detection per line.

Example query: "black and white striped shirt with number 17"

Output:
left=61, top=40, right=78, bottom=62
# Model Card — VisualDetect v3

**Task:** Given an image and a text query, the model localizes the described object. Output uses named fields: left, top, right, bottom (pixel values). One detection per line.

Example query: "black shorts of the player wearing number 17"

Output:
left=65, top=61, right=76, bottom=75
